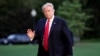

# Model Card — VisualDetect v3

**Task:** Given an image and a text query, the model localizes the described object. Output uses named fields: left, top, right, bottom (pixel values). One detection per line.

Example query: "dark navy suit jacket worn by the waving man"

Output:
left=35, top=17, right=72, bottom=56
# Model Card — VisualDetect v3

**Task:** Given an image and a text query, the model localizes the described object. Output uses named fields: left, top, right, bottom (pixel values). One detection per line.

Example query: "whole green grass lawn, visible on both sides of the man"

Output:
left=0, top=42, right=100, bottom=56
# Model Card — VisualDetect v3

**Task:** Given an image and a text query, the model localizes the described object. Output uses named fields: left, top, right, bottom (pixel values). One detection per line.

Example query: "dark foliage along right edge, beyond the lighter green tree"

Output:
left=83, top=0, right=100, bottom=39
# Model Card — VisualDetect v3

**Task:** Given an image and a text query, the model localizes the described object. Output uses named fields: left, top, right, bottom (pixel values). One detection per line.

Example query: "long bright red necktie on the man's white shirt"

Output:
left=43, top=20, right=49, bottom=51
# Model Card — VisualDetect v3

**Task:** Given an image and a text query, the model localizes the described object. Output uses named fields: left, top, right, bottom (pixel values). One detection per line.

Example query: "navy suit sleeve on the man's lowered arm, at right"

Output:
left=62, top=21, right=73, bottom=56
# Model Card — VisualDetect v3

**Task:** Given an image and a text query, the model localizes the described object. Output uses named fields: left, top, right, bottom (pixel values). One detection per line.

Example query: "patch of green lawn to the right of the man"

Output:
left=74, top=42, right=100, bottom=56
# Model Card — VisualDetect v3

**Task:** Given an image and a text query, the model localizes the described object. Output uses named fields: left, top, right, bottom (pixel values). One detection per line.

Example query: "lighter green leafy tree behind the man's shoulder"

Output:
left=57, top=0, right=91, bottom=37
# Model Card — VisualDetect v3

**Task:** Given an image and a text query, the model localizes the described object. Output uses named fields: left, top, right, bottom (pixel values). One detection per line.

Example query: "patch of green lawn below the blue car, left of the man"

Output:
left=0, top=45, right=38, bottom=56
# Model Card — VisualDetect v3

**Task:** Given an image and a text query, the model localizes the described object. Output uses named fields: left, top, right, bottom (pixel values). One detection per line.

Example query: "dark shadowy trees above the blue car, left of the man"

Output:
left=0, top=0, right=39, bottom=37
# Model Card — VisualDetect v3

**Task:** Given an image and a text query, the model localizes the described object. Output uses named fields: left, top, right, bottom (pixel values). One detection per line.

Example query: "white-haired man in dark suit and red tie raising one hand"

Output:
left=27, top=3, right=72, bottom=56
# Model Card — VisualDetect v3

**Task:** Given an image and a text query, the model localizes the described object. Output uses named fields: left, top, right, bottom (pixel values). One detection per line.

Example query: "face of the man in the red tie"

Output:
left=43, top=6, right=54, bottom=19
